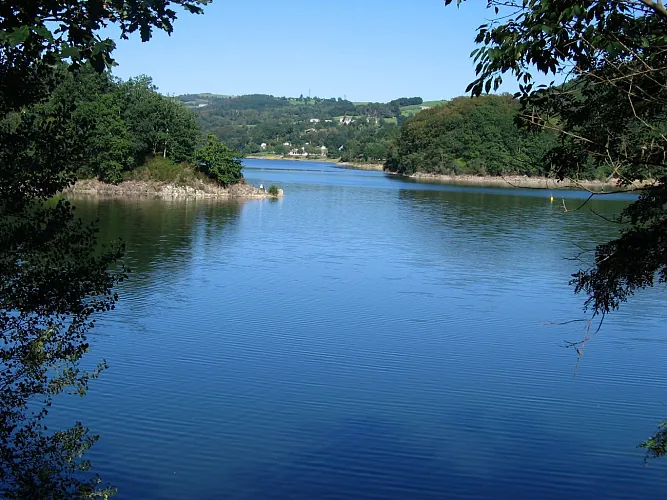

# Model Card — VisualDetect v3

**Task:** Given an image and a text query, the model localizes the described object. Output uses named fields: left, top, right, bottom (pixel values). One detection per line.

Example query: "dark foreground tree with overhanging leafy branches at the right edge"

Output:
left=445, top=0, right=667, bottom=456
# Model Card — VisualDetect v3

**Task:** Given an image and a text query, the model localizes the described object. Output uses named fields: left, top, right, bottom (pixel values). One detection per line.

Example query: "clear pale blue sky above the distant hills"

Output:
left=108, top=0, right=515, bottom=101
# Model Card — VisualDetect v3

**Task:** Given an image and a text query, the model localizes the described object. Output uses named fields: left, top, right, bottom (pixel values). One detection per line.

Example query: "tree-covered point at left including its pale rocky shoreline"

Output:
left=43, top=69, right=283, bottom=199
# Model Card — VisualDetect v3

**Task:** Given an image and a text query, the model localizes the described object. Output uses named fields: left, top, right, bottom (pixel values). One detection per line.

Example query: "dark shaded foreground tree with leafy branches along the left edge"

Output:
left=0, top=0, right=207, bottom=498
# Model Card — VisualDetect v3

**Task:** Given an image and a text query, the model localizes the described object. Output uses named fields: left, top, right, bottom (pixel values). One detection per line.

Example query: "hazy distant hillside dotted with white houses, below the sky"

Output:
left=176, top=94, right=442, bottom=162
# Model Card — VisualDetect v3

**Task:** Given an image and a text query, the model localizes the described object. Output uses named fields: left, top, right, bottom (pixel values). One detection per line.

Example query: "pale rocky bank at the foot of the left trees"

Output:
left=63, top=180, right=283, bottom=200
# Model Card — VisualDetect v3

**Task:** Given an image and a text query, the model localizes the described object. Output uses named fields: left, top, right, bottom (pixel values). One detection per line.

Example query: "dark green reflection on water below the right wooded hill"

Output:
left=399, top=187, right=629, bottom=263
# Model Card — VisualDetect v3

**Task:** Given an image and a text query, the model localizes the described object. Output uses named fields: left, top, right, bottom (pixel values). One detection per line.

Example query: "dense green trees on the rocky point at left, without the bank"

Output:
left=34, top=64, right=240, bottom=184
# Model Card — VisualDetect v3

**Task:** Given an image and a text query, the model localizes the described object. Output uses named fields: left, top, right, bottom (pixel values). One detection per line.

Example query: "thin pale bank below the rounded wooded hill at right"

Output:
left=394, top=172, right=643, bottom=189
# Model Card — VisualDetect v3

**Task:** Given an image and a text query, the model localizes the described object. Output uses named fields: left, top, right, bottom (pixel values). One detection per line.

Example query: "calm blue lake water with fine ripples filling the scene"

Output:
left=60, top=160, right=667, bottom=500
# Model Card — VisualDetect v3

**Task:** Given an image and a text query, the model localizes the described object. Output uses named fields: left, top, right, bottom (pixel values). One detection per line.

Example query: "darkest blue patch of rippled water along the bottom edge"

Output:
left=183, top=411, right=632, bottom=500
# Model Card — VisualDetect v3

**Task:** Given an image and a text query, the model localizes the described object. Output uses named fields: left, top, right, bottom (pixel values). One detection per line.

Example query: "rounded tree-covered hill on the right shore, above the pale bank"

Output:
left=385, top=95, right=554, bottom=176
